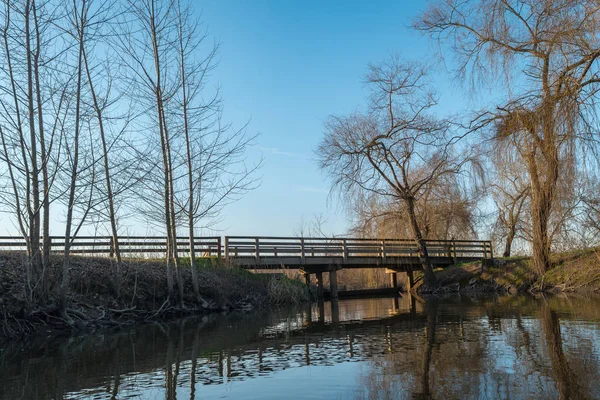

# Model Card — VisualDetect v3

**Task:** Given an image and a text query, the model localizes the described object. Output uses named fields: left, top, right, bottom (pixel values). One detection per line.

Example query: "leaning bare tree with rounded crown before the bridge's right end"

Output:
left=317, top=58, right=469, bottom=285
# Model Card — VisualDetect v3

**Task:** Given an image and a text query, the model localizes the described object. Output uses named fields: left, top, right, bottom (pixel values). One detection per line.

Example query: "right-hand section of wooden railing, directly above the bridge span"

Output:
left=224, top=236, right=493, bottom=260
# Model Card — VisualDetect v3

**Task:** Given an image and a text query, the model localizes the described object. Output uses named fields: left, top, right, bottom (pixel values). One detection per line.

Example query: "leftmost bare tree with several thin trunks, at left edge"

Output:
left=0, top=1, right=69, bottom=291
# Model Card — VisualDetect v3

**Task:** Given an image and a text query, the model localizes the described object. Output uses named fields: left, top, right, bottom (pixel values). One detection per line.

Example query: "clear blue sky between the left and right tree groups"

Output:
left=198, top=0, right=478, bottom=235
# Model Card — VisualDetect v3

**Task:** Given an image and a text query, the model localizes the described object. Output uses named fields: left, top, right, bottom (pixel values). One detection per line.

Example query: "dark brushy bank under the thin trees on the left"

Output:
left=0, top=253, right=309, bottom=339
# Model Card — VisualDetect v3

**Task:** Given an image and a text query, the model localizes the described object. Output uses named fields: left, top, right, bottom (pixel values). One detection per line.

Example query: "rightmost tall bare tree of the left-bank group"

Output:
left=168, top=0, right=260, bottom=298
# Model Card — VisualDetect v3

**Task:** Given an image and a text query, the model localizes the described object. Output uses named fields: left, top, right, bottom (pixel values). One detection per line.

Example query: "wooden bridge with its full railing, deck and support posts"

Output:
left=0, top=236, right=494, bottom=298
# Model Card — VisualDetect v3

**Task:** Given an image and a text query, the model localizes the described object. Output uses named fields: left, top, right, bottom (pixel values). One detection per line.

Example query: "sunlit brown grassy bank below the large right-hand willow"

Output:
left=414, top=248, right=600, bottom=294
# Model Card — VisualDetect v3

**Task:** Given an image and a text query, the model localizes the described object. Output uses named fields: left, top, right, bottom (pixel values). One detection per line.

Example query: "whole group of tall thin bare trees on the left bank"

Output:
left=0, top=0, right=258, bottom=307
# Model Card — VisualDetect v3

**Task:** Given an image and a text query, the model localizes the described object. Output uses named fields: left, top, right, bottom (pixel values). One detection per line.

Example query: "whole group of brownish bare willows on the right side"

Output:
left=317, top=0, right=600, bottom=284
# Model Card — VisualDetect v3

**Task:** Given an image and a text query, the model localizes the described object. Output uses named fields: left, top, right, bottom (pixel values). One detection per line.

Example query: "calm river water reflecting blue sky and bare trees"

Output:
left=0, top=297, right=600, bottom=400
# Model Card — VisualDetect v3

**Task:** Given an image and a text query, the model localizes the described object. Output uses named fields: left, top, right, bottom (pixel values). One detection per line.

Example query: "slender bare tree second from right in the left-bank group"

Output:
left=115, top=0, right=178, bottom=300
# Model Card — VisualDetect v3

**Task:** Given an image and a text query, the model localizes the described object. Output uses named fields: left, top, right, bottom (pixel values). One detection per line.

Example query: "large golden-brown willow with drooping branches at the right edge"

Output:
left=415, top=0, right=600, bottom=273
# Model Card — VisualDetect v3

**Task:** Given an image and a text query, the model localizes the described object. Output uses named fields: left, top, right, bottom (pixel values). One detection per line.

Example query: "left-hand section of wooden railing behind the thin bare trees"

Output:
left=0, top=236, right=222, bottom=258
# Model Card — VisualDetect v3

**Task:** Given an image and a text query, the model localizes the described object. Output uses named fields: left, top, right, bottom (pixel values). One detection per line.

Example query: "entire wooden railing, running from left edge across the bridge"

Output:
left=0, top=236, right=493, bottom=260
